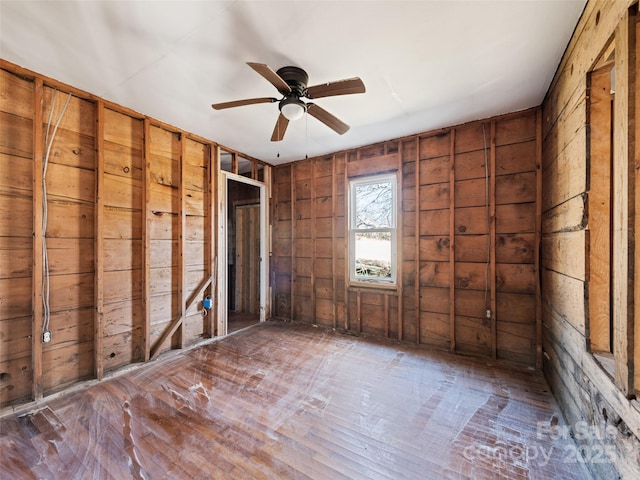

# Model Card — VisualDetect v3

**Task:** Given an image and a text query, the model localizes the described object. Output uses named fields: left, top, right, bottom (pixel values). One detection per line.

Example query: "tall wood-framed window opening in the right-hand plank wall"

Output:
left=585, top=6, right=640, bottom=396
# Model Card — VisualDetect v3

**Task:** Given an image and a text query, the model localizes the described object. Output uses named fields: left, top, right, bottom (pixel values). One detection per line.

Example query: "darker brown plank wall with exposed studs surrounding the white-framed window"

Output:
left=272, top=109, right=541, bottom=366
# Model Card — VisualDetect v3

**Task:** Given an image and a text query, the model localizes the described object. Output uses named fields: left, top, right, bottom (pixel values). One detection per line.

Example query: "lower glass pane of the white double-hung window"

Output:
left=354, top=232, right=391, bottom=280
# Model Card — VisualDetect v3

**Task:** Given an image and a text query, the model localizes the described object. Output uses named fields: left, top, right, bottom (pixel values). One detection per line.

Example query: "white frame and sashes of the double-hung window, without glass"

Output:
left=347, top=172, right=399, bottom=287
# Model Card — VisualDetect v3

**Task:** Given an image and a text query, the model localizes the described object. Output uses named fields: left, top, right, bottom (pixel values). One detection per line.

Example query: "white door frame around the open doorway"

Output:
left=217, top=170, right=269, bottom=336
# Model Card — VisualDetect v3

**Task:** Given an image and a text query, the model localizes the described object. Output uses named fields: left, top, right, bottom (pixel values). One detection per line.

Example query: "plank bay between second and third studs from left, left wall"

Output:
left=98, top=108, right=144, bottom=371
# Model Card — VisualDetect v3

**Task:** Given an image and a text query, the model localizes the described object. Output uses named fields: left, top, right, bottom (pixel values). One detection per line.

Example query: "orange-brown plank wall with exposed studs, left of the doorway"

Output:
left=0, top=61, right=267, bottom=407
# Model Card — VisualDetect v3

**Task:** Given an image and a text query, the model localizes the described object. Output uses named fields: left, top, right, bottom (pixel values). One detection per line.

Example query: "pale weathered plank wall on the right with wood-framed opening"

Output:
left=541, top=1, right=640, bottom=478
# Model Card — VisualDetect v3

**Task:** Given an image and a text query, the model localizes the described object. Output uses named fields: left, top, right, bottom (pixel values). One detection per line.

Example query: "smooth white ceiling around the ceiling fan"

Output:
left=0, top=0, right=586, bottom=164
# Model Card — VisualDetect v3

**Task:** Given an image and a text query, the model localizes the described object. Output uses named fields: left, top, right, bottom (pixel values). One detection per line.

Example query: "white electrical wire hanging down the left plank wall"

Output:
left=42, top=89, right=71, bottom=338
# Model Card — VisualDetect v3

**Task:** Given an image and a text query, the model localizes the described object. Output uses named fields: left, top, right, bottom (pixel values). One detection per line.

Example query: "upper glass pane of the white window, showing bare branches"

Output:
left=354, top=181, right=394, bottom=229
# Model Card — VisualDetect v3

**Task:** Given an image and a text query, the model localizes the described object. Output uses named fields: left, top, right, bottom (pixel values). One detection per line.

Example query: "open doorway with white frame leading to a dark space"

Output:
left=218, top=172, right=267, bottom=335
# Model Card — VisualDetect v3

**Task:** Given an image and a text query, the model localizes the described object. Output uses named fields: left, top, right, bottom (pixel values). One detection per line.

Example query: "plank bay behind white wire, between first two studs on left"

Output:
left=34, top=87, right=97, bottom=394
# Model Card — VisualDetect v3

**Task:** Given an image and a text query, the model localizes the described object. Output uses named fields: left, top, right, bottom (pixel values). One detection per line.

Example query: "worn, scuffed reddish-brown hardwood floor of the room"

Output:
left=0, top=322, right=589, bottom=480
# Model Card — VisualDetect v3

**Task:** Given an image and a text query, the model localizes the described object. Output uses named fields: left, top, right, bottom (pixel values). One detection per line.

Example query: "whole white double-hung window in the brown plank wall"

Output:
left=349, top=175, right=397, bottom=285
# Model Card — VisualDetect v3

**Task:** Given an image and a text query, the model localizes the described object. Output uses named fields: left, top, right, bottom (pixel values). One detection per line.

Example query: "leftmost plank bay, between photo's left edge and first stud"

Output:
left=0, top=70, right=35, bottom=404
